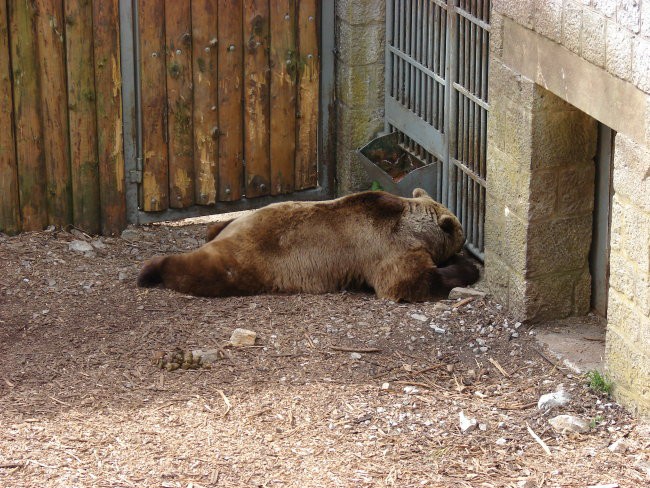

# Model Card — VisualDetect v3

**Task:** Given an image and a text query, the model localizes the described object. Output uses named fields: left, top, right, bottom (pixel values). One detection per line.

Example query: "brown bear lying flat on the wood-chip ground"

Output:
left=138, top=189, right=479, bottom=302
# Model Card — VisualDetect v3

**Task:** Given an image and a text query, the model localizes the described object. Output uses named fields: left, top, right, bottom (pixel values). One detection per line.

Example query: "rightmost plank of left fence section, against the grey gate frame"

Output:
left=92, top=0, right=130, bottom=235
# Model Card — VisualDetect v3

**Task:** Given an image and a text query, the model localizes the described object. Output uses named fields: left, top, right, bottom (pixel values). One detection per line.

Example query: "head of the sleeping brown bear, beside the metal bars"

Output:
left=413, top=188, right=465, bottom=263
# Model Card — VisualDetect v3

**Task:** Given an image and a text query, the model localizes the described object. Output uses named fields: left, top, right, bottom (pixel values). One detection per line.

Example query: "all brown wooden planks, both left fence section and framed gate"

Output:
left=0, top=0, right=320, bottom=234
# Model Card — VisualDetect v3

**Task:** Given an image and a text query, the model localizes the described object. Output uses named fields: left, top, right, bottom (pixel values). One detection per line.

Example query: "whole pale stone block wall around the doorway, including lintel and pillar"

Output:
left=492, top=0, right=650, bottom=414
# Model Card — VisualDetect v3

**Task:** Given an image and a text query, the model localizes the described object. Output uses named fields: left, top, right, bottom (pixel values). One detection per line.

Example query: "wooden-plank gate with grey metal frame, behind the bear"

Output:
left=120, top=0, right=334, bottom=223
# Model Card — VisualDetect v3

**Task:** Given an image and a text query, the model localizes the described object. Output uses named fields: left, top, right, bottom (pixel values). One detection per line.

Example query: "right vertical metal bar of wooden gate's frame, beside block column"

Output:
left=318, top=2, right=336, bottom=195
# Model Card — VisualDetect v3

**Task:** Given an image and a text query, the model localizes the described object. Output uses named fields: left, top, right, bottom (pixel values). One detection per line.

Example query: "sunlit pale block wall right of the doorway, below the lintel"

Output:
left=606, top=134, right=650, bottom=414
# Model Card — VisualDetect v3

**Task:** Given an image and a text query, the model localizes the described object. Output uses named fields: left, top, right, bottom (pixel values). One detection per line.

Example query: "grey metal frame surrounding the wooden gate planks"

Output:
left=119, top=0, right=335, bottom=224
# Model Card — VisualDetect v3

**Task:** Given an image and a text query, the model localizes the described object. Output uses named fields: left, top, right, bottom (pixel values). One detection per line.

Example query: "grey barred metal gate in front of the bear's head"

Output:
left=386, top=0, right=490, bottom=259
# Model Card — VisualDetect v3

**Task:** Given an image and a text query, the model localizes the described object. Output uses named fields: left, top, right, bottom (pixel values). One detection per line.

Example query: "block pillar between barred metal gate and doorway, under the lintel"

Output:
left=485, top=58, right=597, bottom=320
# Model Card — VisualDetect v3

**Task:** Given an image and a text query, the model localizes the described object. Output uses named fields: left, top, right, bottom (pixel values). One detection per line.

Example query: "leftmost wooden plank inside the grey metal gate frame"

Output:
left=138, top=0, right=169, bottom=212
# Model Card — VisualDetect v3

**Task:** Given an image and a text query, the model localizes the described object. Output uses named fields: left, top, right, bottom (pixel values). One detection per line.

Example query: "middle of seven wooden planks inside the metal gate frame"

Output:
left=218, top=0, right=244, bottom=201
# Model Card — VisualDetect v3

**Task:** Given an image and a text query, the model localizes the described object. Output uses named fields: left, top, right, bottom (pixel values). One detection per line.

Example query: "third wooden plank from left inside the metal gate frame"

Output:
left=192, top=0, right=223, bottom=205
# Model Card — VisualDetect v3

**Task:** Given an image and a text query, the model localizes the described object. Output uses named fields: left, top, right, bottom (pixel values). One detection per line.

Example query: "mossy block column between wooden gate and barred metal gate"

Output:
left=335, top=0, right=386, bottom=194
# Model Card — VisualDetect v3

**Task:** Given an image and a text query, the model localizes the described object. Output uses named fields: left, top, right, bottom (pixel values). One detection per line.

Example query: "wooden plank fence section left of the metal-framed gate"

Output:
left=0, top=0, right=126, bottom=234
